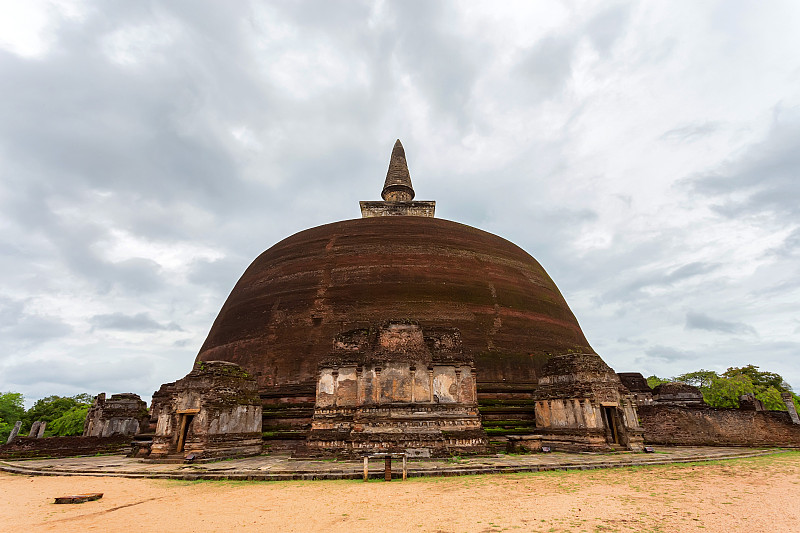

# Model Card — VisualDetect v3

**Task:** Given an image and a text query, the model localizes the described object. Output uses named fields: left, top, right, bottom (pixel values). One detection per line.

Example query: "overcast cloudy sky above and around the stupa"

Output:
left=0, top=0, right=800, bottom=402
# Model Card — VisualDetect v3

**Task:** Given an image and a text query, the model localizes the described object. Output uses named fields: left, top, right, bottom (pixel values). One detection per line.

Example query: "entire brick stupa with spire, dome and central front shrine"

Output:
left=196, top=140, right=641, bottom=452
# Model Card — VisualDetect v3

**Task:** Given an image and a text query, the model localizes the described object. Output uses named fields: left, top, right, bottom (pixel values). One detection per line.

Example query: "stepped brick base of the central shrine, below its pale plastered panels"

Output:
left=307, top=404, right=488, bottom=457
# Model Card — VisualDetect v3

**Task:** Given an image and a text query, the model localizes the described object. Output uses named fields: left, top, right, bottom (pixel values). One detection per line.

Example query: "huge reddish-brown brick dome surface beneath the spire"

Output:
left=197, top=216, right=593, bottom=396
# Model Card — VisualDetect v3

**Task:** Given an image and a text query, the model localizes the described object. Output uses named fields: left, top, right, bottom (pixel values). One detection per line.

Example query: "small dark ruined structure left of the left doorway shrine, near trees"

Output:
left=83, top=392, right=150, bottom=437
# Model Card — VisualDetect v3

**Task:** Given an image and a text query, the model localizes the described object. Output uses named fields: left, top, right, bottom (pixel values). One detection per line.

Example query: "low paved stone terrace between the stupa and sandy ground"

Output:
left=0, top=447, right=782, bottom=481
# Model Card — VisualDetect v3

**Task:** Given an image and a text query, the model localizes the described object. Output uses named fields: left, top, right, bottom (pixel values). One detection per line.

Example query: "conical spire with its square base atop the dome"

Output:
left=359, top=139, right=436, bottom=218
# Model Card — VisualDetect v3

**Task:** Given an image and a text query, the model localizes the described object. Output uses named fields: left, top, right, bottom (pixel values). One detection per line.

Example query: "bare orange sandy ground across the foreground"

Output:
left=0, top=452, right=800, bottom=533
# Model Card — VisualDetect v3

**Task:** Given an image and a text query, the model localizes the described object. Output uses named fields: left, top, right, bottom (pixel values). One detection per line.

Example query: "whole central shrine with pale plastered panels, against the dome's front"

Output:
left=307, top=322, right=487, bottom=457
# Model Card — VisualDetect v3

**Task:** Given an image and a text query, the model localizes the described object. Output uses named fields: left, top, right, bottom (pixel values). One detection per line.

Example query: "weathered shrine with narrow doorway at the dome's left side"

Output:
left=149, top=361, right=262, bottom=460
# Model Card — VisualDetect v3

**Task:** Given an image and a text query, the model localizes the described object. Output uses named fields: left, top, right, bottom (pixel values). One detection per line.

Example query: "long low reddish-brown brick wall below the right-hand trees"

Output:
left=639, top=405, right=800, bottom=446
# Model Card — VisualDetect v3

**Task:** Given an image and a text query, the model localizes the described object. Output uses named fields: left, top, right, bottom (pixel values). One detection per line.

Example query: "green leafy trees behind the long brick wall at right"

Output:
left=647, top=365, right=800, bottom=411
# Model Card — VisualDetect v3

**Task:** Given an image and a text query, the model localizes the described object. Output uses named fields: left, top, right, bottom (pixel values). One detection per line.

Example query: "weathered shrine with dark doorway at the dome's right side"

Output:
left=533, top=353, right=643, bottom=451
